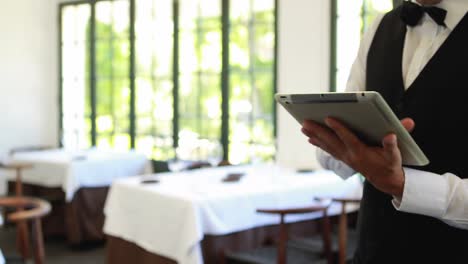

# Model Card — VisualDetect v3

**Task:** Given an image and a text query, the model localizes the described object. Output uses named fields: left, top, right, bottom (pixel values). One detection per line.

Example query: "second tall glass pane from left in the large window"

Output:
left=96, top=0, right=130, bottom=150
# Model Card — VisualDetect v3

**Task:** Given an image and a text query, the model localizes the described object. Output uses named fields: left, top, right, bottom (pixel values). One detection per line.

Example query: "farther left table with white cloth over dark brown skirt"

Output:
left=5, top=149, right=152, bottom=244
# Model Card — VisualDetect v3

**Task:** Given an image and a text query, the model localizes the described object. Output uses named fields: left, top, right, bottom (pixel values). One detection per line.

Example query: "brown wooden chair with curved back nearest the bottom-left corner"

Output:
left=0, top=197, right=51, bottom=264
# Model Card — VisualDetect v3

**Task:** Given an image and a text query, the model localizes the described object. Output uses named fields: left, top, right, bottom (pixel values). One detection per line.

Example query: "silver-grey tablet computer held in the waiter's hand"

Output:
left=275, top=92, right=429, bottom=166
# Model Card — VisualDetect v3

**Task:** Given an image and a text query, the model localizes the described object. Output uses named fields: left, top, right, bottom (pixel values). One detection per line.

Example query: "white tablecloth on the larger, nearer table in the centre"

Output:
left=104, top=165, right=362, bottom=264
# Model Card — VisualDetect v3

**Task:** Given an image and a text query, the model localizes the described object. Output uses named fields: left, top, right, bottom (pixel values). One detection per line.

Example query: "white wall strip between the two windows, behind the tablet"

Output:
left=277, top=0, right=330, bottom=168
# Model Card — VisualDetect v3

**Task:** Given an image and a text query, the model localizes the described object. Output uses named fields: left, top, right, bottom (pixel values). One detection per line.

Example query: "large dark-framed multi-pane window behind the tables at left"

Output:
left=60, top=0, right=276, bottom=163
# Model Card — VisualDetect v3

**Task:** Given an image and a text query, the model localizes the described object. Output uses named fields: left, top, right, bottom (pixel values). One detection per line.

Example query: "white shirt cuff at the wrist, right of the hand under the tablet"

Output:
left=392, top=168, right=448, bottom=218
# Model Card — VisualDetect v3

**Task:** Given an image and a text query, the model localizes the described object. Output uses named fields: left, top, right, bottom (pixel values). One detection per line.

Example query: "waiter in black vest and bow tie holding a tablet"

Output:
left=302, top=0, right=468, bottom=264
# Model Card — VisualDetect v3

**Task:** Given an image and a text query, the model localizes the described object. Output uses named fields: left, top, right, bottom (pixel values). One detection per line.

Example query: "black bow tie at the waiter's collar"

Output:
left=401, top=1, right=447, bottom=27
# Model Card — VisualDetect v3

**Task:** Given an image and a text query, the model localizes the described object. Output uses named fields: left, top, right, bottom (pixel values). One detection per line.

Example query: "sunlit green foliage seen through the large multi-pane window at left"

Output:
left=62, top=0, right=275, bottom=163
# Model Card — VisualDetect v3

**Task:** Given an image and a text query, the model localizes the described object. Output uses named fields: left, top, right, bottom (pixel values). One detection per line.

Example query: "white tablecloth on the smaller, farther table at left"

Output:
left=7, top=149, right=151, bottom=201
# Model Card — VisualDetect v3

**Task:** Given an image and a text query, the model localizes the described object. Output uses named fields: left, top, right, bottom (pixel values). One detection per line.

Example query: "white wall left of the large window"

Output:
left=0, top=0, right=58, bottom=155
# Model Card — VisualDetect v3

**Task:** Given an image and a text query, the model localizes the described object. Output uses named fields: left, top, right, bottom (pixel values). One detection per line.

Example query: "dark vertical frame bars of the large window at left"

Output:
left=58, top=0, right=279, bottom=163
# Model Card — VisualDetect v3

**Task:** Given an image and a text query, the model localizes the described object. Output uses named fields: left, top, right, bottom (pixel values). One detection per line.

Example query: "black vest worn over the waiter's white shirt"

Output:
left=355, top=4, right=468, bottom=264
